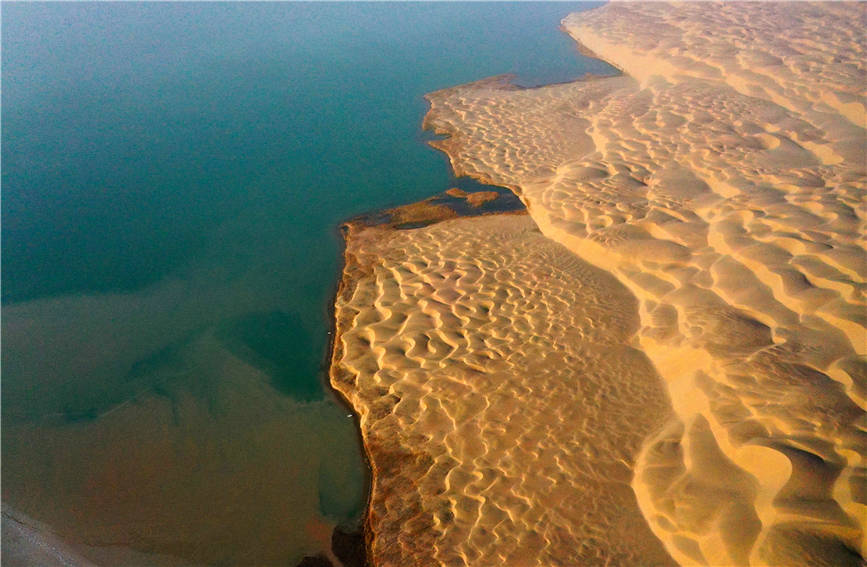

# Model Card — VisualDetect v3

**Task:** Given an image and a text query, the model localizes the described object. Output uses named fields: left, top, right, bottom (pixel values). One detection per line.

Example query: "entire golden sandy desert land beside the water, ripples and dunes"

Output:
left=331, top=3, right=867, bottom=567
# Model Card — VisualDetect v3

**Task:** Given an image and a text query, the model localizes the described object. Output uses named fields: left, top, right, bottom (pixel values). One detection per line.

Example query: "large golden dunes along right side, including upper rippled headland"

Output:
left=426, top=3, right=867, bottom=565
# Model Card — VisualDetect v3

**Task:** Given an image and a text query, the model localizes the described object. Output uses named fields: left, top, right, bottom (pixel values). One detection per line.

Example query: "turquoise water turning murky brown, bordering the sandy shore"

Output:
left=2, top=3, right=613, bottom=563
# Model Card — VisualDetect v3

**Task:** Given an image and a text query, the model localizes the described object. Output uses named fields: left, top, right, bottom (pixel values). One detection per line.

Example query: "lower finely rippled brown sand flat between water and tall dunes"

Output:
left=332, top=215, right=673, bottom=567
